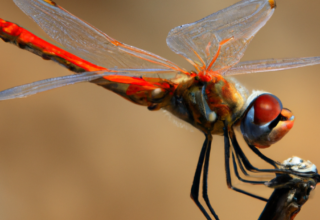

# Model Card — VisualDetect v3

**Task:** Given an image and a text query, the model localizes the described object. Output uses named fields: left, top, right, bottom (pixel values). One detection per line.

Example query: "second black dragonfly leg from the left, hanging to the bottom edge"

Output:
left=202, top=134, right=219, bottom=219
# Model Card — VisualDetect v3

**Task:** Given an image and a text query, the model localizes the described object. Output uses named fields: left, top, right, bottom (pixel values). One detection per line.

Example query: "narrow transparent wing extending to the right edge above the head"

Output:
left=225, top=57, right=320, bottom=76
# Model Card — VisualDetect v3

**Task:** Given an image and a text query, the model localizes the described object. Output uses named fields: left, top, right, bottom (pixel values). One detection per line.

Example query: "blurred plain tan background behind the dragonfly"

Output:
left=0, top=0, right=320, bottom=220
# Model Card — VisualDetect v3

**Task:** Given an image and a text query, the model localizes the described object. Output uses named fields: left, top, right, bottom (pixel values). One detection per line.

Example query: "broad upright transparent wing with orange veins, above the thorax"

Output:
left=167, top=0, right=275, bottom=73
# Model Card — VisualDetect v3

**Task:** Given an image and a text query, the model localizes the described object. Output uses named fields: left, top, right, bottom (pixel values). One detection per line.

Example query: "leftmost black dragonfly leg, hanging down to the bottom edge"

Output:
left=190, top=136, right=218, bottom=220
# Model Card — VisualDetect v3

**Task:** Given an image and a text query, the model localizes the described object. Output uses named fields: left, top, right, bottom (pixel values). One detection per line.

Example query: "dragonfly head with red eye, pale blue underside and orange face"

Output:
left=240, top=93, right=295, bottom=148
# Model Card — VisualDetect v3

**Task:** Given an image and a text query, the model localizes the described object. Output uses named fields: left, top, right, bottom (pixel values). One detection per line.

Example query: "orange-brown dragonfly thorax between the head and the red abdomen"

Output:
left=165, top=74, right=247, bottom=134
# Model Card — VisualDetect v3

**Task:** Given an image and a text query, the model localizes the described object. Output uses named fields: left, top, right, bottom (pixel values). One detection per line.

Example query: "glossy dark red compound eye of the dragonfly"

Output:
left=253, top=95, right=281, bottom=125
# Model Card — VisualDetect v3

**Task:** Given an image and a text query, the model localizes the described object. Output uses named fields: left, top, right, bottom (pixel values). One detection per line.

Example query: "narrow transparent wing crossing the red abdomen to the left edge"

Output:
left=0, top=69, right=177, bottom=100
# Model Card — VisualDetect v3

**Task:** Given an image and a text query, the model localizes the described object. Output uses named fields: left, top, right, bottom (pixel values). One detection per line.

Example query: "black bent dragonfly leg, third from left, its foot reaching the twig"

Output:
left=224, top=127, right=268, bottom=202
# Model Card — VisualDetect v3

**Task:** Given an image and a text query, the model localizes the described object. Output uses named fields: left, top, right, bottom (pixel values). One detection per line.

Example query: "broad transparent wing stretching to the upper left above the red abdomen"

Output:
left=13, top=0, right=186, bottom=72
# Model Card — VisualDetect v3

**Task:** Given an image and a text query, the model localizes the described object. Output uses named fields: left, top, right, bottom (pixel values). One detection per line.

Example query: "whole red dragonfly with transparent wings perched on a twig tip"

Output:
left=0, top=0, right=320, bottom=219
